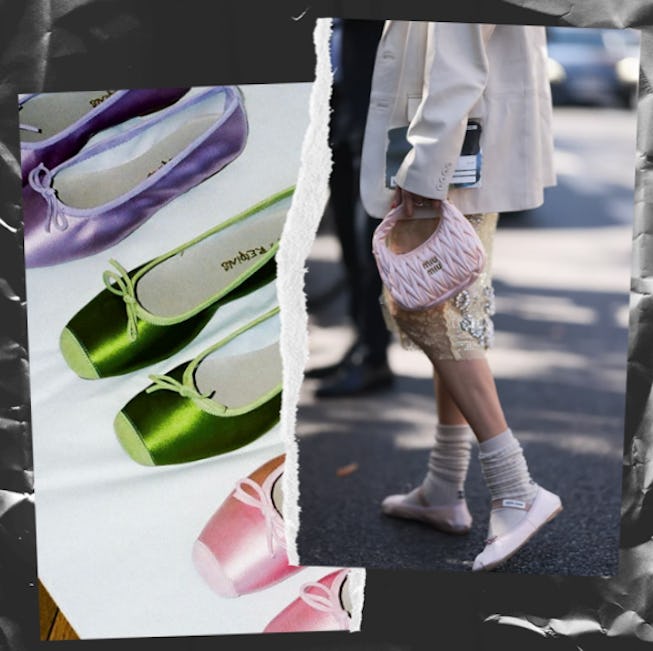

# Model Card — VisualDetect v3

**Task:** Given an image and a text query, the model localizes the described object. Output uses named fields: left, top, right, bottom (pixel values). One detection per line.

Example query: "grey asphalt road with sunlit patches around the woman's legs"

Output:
left=297, top=108, right=636, bottom=576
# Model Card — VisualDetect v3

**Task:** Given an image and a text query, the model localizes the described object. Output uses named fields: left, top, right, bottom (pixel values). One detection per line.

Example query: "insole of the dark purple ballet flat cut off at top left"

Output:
left=19, top=90, right=115, bottom=142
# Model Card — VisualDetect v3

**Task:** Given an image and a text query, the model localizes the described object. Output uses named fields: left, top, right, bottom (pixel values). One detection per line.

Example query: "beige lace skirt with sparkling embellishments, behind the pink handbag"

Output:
left=381, top=213, right=498, bottom=360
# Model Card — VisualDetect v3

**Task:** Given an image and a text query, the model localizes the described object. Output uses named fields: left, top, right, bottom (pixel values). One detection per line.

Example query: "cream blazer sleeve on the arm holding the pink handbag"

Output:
left=396, top=23, right=495, bottom=199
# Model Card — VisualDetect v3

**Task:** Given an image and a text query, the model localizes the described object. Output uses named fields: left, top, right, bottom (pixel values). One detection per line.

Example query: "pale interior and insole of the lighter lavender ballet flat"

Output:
left=54, top=93, right=225, bottom=209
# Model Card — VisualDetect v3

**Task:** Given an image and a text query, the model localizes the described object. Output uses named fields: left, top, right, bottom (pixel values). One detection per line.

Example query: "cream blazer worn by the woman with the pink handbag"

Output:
left=361, top=21, right=555, bottom=217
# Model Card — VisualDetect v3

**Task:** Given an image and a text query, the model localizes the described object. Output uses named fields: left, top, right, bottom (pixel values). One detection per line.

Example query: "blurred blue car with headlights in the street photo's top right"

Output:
left=547, top=27, right=640, bottom=107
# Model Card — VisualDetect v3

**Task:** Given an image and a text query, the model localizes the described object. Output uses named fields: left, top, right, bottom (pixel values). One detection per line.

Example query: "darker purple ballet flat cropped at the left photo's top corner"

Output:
left=18, top=88, right=188, bottom=185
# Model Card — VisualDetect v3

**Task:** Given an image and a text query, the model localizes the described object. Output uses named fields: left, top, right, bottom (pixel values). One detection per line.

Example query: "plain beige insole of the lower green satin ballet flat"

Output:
left=195, top=343, right=281, bottom=409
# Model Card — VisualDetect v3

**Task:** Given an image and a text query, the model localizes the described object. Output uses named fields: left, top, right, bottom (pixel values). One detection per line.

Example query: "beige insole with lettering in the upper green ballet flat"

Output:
left=136, top=197, right=291, bottom=317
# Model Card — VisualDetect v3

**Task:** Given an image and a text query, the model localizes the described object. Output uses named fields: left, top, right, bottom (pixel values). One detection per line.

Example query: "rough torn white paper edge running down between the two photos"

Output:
left=277, top=18, right=365, bottom=631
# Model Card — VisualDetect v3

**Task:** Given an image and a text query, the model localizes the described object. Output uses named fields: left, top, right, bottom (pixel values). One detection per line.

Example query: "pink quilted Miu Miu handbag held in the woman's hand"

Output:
left=372, top=201, right=485, bottom=311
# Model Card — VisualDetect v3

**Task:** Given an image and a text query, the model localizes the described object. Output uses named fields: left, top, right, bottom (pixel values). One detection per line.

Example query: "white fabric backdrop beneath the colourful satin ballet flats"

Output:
left=27, top=84, right=344, bottom=638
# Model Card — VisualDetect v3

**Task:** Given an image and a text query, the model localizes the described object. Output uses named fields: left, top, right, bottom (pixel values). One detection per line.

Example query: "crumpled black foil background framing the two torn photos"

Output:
left=0, top=0, right=653, bottom=651
